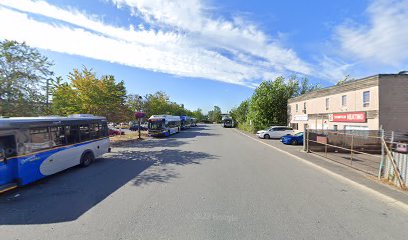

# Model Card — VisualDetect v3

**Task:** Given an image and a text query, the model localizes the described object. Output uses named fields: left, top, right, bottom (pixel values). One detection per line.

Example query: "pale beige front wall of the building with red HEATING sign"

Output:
left=288, top=75, right=379, bottom=131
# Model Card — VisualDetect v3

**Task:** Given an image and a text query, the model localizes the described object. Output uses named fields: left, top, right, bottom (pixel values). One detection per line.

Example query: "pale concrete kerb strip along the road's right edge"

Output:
left=234, top=129, right=408, bottom=213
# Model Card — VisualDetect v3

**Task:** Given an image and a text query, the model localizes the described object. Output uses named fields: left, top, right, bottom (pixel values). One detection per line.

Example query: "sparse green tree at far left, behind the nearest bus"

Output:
left=0, top=40, right=53, bottom=116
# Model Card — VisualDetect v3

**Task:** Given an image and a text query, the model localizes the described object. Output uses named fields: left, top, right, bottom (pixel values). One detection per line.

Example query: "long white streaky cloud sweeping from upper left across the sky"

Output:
left=0, top=0, right=311, bottom=87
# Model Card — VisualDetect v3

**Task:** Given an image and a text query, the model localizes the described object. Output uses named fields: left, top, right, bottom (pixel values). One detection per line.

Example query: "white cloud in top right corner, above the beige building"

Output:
left=336, top=0, right=408, bottom=67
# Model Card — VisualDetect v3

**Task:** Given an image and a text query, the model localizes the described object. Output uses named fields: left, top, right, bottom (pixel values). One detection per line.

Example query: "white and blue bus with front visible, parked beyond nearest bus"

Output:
left=148, top=115, right=181, bottom=137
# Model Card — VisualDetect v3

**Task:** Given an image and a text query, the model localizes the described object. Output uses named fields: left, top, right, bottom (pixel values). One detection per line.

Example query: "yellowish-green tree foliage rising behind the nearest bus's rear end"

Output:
left=52, top=67, right=132, bottom=122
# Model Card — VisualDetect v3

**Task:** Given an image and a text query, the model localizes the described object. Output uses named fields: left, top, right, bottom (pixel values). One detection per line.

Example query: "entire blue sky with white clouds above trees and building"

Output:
left=0, top=0, right=408, bottom=112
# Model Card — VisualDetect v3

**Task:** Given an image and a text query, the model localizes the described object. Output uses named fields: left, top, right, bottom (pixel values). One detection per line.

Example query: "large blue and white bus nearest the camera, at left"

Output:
left=0, top=114, right=110, bottom=193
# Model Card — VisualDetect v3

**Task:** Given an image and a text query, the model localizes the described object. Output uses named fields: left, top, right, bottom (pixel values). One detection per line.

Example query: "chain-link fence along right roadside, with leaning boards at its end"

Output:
left=304, top=129, right=408, bottom=189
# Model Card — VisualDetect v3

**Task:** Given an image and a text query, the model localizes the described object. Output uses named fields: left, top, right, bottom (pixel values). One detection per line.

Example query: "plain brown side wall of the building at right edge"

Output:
left=379, top=74, right=408, bottom=132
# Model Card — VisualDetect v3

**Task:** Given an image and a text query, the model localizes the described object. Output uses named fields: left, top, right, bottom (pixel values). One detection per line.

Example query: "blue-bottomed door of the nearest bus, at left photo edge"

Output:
left=0, top=135, right=17, bottom=188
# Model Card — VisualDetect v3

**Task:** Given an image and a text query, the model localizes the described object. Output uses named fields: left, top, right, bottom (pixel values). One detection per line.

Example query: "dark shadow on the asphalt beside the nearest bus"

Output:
left=0, top=149, right=216, bottom=225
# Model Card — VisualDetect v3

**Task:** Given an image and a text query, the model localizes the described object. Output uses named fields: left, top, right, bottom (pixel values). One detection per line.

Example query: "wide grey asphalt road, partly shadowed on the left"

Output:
left=0, top=125, right=408, bottom=240
